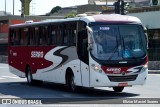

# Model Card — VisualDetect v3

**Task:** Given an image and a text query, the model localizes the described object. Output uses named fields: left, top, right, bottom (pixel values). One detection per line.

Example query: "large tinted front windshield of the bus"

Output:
left=91, top=24, right=147, bottom=60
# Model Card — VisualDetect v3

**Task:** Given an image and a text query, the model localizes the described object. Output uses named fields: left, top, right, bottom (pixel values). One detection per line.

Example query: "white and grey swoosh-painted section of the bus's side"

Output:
left=33, top=47, right=82, bottom=86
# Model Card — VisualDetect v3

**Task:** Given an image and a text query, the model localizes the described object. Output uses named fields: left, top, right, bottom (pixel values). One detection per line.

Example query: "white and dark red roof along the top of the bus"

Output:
left=10, top=14, right=141, bottom=28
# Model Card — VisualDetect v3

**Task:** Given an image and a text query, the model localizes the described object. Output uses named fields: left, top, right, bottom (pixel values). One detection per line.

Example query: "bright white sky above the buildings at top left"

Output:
left=0, top=0, right=88, bottom=15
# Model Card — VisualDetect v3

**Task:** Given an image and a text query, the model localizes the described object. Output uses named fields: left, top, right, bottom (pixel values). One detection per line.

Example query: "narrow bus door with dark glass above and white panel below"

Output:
left=77, top=30, right=90, bottom=87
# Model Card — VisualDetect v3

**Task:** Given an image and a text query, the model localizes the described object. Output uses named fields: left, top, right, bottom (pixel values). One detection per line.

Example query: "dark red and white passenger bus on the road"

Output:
left=8, top=14, right=148, bottom=92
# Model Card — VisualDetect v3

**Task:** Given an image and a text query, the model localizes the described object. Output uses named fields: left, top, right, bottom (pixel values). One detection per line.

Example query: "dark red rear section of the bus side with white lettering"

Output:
left=9, top=46, right=53, bottom=73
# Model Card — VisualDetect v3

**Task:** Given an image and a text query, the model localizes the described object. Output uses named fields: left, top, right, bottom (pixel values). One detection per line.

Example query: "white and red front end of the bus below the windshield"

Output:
left=90, top=52, right=148, bottom=87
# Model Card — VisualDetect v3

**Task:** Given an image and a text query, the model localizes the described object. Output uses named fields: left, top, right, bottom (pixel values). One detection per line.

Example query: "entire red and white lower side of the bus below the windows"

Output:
left=10, top=46, right=82, bottom=86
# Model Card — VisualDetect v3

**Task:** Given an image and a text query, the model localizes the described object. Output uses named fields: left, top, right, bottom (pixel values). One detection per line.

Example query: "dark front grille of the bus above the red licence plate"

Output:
left=108, top=75, right=138, bottom=82
